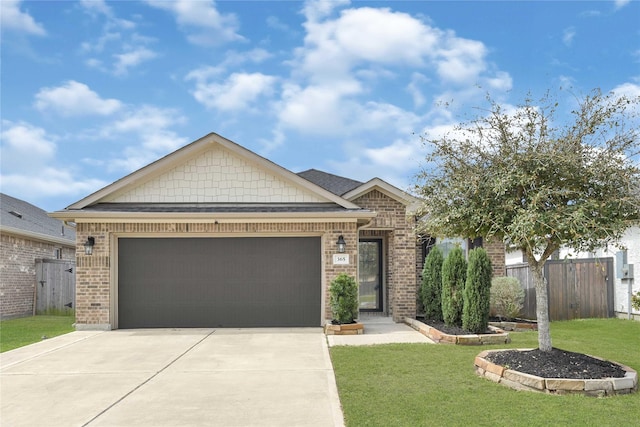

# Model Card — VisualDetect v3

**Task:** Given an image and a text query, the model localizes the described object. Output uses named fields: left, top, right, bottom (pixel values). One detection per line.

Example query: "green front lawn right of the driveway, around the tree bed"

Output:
left=331, top=319, right=640, bottom=427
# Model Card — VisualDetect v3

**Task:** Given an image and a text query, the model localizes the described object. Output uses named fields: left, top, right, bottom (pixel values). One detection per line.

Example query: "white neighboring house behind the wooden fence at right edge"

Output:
left=506, top=226, right=640, bottom=318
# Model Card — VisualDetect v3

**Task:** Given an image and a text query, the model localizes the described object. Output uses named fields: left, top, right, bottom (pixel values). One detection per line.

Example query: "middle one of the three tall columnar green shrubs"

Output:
left=442, top=247, right=467, bottom=326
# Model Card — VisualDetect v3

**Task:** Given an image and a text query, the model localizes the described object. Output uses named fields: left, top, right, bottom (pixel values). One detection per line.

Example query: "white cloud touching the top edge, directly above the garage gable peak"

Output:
left=147, top=0, right=244, bottom=46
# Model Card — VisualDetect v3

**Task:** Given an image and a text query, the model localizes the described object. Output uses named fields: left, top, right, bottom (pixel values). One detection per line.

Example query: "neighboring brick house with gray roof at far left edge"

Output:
left=0, top=193, right=76, bottom=319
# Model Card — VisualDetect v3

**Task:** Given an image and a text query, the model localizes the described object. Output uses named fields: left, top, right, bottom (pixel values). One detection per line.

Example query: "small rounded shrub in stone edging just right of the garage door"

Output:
left=325, top=273, right=364, bottom=335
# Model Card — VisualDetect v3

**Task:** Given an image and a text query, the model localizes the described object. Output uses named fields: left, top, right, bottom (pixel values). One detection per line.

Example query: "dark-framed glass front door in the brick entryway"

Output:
left=358, top=239, right=383, bottom=311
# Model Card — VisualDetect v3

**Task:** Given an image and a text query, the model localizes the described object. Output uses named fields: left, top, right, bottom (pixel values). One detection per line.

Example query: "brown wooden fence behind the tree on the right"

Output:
left=507, top=258, right=614, bottom=320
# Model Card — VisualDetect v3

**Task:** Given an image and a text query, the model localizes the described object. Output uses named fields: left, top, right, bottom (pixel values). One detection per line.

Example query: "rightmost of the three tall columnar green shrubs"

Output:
left=462, top=248, right=493, bottom=334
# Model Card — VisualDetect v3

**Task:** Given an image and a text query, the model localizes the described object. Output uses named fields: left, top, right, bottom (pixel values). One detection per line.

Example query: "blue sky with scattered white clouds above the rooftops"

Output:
left=0, top=0, right=640, bottom=210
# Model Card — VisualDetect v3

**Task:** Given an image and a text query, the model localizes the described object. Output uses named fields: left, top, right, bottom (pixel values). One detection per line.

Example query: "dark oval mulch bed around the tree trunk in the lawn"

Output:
left=486, top=348, right=625, bottom=379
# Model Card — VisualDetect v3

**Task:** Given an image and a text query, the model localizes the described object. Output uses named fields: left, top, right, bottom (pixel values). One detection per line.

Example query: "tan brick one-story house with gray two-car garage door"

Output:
left=51, top=134, right=504, bottom=329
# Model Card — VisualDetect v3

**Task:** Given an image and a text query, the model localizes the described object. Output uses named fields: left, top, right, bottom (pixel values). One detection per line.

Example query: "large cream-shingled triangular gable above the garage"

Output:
left=67, top=133, right=358, bottom=209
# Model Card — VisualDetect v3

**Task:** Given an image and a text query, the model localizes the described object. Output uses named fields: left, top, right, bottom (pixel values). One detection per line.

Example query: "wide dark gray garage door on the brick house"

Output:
left=118, top=237, right=322, bottom=328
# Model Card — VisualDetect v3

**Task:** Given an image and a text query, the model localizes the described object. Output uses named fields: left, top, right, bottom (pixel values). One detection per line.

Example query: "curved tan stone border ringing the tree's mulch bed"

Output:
left=475, top=348, right=638, bottom=397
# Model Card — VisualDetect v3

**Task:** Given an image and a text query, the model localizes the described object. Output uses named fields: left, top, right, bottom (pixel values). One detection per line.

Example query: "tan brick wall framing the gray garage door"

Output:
left=76, top=221, right=358, bottom=329
